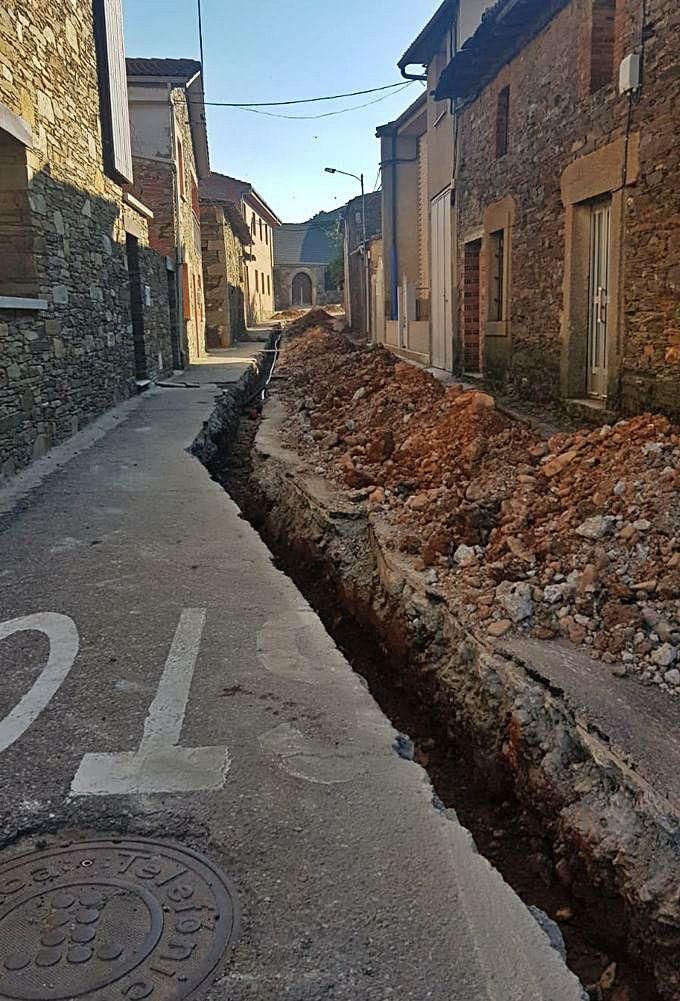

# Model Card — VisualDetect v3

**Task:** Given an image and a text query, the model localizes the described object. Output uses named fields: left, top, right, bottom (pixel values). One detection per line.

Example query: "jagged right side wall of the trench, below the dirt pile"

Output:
left=248, top=399, right=680, bottom=1001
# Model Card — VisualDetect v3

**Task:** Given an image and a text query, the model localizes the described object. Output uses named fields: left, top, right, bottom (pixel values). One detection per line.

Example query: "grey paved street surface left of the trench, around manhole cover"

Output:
left=0, top=344, right=583, bottom=1001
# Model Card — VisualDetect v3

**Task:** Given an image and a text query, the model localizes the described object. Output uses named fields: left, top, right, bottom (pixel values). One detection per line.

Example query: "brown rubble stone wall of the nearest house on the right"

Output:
left=457, top=0, right=680, bottom=416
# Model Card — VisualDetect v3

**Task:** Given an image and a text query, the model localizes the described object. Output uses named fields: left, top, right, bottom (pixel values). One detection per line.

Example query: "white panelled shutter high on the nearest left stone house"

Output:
left=93, top=0, right=132, bottom=182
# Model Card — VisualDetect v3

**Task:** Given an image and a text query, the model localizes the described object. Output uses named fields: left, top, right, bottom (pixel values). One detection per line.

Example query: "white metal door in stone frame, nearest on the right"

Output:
left=588, top=202, right=612, bottom=399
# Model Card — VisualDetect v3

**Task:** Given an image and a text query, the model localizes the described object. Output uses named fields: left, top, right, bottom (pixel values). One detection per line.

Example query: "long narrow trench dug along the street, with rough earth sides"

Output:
left=194, top=354, right=680, bottom=1001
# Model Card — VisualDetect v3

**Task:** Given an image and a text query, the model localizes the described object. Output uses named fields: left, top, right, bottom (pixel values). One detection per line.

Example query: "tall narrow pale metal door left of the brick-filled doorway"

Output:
left=431, top=189, right=454, bottom=371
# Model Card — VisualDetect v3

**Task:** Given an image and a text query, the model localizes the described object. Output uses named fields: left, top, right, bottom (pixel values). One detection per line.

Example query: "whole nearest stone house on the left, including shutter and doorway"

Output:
left=0, top=0, right=172, bottom=476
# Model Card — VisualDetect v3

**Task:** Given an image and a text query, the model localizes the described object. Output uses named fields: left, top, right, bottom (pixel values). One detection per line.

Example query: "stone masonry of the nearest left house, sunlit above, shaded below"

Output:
left=0, top=0, right=171, bottom=476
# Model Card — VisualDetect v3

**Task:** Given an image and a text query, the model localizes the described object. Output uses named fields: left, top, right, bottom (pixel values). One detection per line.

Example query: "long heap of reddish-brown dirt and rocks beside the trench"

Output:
left=276, top=326, right=680, bottom=693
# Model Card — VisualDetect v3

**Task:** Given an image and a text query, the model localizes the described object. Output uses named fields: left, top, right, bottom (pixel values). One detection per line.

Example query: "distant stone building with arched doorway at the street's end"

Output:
left=274, top=221, right=342, bottom=309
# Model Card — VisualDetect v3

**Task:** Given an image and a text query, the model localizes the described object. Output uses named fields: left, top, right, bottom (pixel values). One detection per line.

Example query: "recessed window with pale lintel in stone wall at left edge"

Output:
left=0, top=114, right=38, bottom=298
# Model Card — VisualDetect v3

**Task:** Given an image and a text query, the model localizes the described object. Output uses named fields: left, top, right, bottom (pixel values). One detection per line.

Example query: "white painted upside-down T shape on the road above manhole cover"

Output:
left=71, top=609, right=231, bottom=796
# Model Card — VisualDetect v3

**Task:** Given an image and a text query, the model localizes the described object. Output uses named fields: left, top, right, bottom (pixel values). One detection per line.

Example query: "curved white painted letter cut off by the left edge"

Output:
left=0, top=612, right=80, bottom=753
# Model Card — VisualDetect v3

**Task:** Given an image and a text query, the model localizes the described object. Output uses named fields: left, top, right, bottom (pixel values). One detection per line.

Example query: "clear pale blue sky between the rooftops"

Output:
left=123, top=0, right=438, bottom=222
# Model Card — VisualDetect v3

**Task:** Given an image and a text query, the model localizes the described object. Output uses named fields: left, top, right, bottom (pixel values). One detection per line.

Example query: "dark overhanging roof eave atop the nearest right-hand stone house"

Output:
left=435, top=0, right=570, bottom=102
